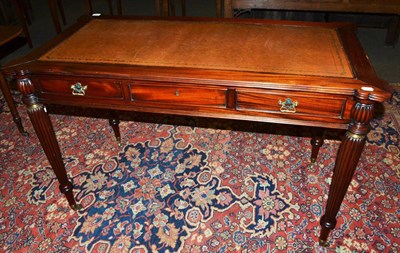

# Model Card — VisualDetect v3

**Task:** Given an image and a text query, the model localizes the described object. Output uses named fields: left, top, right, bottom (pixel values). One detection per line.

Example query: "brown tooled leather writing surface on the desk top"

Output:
left=40, top=19, right=353, bottom=77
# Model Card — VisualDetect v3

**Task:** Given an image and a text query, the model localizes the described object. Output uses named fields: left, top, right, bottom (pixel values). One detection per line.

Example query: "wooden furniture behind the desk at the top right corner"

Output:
left=224, top=0, right=400, bottom=46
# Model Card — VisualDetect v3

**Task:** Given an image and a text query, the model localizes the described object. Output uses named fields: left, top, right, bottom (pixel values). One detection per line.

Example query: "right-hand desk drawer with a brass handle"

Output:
left=237, top=89, right=353, bottom=118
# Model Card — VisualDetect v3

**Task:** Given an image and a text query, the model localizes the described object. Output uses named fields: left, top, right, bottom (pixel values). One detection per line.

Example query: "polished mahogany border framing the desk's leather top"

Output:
left=2, top=16, right=392, bottom=102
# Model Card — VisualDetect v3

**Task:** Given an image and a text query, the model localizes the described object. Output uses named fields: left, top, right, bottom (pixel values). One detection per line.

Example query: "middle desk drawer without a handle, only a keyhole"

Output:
left=129, top=82, right=226, bottom=107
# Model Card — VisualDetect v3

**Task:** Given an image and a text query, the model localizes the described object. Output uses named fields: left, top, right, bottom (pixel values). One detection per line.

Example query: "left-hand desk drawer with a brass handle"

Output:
left=37, top=77, right=123, bottom=99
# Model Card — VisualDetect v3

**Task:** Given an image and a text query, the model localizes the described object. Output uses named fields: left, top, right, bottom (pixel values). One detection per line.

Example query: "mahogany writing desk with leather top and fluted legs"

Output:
left=3, top=15, right=391, bottom=243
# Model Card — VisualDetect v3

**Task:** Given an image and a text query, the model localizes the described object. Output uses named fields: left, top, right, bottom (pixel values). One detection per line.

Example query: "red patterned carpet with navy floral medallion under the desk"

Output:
left=0, top=86, right=400, bottom=253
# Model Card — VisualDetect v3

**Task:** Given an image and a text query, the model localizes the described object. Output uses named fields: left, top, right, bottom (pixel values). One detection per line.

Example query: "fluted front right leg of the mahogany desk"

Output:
left=319, top=101, right=374, bottom=246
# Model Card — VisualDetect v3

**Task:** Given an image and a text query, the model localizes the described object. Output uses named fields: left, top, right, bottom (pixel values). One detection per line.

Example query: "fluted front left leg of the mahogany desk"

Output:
left=17, top=74, right=82, bottom=210
